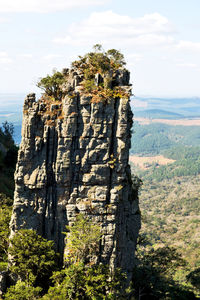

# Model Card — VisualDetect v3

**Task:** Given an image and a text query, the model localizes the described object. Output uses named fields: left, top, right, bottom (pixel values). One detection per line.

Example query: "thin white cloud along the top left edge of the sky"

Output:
left=0, top=0, right=109, bottom=13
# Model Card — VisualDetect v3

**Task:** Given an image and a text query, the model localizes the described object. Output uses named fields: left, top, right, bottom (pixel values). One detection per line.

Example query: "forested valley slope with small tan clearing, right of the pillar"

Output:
left=130, top=119, right=200, bottom=299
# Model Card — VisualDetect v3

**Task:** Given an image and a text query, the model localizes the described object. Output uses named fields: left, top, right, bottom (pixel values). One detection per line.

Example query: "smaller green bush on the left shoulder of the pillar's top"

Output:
left=37, top=71, right=65, bottom=100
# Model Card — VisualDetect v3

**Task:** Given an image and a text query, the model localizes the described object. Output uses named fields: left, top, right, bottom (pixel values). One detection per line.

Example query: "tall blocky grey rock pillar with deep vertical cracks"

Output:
left=11, top=68, right=140, bottom=274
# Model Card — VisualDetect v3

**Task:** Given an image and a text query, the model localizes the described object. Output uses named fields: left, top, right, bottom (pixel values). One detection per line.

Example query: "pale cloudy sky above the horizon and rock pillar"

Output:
left=0, top=0, right=200, bottom=97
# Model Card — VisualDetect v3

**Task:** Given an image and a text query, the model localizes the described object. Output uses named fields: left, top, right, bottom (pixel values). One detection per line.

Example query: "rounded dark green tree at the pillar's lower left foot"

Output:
left=9, top=229, right=56, bottom=286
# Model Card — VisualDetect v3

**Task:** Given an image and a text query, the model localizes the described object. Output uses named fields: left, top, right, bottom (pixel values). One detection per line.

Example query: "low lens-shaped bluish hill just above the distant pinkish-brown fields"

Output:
left=134, top=109, right=184, bottom=119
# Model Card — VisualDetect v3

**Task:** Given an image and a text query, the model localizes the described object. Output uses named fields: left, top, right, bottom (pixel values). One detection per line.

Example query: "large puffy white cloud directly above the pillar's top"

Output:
left=53, top=11, right=174, bottom=45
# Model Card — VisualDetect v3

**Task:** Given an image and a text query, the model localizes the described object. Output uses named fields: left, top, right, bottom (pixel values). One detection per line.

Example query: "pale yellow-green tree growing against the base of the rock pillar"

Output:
left=65, top=214, right=101, bottom=263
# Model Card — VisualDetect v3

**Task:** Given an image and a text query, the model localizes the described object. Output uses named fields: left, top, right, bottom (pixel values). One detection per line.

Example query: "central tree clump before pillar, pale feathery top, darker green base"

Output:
left=43, top=214, right=126, bottom=300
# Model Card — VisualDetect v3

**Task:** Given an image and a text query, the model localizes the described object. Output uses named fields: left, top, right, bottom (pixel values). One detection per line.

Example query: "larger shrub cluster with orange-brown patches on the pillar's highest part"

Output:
left=72, top=44, right=130, bottom=103
